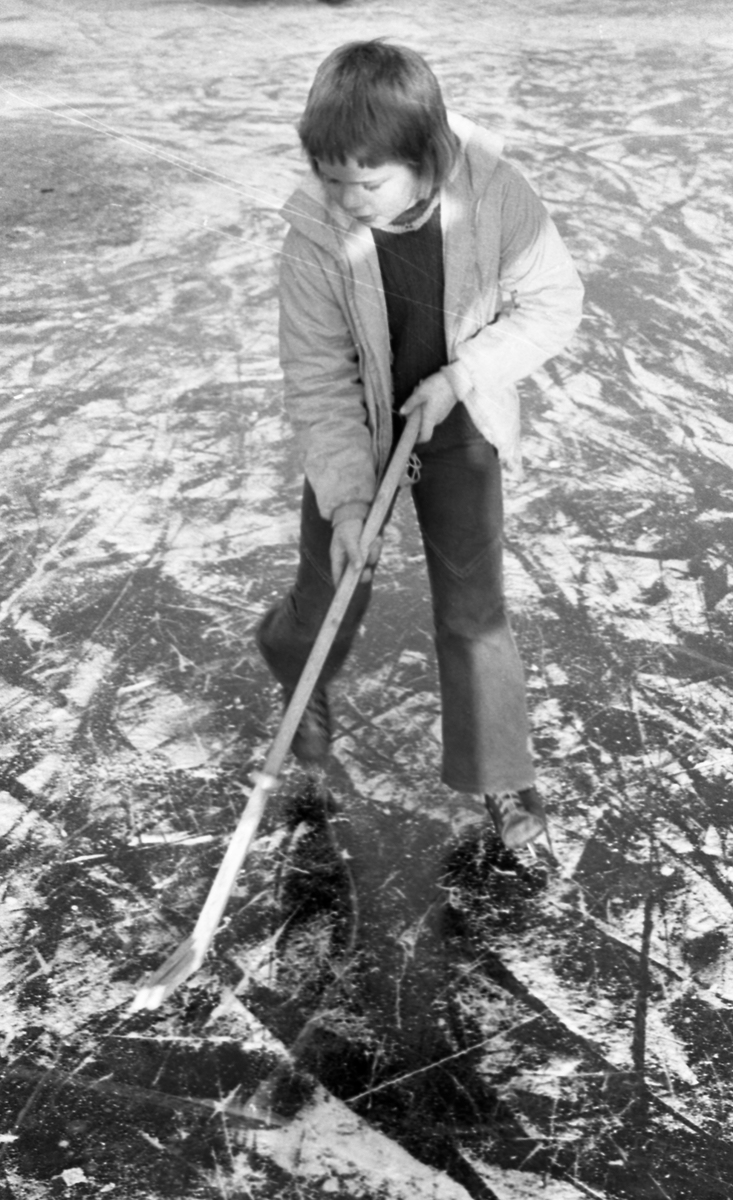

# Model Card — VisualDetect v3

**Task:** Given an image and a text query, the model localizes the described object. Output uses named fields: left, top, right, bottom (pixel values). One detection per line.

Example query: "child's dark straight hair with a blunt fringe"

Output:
left=298, top=38, right=458, bottom=186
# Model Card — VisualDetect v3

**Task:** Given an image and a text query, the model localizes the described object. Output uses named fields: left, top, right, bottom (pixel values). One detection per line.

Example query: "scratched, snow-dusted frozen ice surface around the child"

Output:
left=0, top=0, right=733, bottom=1200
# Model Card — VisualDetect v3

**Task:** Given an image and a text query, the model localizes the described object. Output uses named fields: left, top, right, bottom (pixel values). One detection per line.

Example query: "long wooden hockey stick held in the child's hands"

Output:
left=130, top=412, right=420, bottom=1013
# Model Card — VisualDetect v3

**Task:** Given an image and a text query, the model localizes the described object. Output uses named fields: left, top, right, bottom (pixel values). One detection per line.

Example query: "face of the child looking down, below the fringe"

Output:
left=316, top=158, right=426, bottom=228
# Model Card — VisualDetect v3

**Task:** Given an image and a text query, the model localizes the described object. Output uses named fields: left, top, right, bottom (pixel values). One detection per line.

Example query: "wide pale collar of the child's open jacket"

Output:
left=281, top=113, right=504, bottom=252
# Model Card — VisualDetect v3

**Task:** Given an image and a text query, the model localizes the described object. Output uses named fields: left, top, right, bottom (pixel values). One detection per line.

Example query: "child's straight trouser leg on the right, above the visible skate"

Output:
left=413, top=404, right=534, bottom=793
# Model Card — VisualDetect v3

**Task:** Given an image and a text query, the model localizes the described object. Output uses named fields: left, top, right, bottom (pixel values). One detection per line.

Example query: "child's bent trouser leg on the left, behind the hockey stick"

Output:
left=257, top=481, right=372, bottom=689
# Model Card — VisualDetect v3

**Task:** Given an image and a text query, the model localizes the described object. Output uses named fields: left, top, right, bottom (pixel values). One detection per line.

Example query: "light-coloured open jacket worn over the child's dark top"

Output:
left=280, top=115, right=583, bottom=520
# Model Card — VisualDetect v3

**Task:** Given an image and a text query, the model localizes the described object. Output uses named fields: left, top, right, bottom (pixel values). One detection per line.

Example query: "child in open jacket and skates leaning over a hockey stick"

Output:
left=258, top=40, right=583, bottom=870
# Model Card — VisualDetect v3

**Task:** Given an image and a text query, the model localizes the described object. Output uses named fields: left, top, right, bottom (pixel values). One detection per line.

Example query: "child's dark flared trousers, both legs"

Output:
left=258, top=404, right=535, bottom=793
